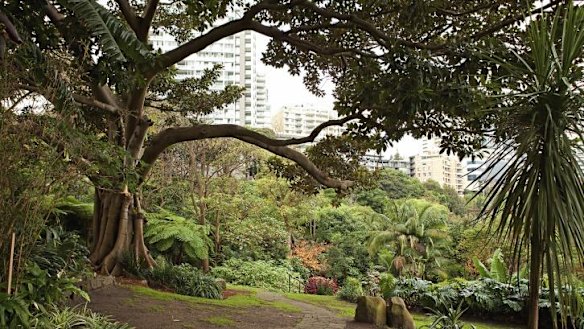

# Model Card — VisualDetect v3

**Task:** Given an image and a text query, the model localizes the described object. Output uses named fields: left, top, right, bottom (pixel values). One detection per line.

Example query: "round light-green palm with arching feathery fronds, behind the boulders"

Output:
left=369, top=200, right=448, bottom=277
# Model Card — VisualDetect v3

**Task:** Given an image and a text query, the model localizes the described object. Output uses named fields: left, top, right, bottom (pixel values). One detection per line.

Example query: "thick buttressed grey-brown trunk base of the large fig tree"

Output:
left=89, top=188, right=154, bottom=275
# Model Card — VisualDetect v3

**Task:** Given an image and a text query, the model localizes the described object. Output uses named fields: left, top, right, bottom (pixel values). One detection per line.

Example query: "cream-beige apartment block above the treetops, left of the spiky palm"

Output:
left=410, top=139, right=467, bottom=194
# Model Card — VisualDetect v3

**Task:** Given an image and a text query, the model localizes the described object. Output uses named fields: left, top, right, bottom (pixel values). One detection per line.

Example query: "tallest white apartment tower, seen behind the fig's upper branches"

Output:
left=150, top=18, right=270, bottom=128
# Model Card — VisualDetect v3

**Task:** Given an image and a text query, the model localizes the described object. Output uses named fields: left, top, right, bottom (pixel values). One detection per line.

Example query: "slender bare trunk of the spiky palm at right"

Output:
left=527, top=236, right=542, bottom=329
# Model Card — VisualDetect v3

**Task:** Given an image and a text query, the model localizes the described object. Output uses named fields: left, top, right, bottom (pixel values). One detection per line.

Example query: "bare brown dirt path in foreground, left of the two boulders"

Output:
left=83, top=286, right=374, bottom=329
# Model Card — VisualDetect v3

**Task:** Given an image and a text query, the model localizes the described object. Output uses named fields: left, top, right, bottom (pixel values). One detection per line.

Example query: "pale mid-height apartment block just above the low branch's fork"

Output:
left=272, top=104, right=342, bottom=139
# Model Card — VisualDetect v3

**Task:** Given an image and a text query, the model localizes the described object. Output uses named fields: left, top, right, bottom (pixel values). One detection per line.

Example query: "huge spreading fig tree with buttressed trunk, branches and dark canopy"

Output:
left=0, top=0, right=561, bottom=284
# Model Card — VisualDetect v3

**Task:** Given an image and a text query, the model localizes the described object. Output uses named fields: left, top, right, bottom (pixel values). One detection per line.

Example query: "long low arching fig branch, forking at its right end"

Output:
left=139, top=121, right=358, bottom=190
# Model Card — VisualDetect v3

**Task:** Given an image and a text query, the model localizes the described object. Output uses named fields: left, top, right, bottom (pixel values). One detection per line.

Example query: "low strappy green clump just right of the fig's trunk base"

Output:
left=145, top=261, right=223, bottom=299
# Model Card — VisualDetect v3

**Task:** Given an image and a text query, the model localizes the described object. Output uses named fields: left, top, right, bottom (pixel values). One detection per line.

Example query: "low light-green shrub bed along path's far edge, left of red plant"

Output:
left=211, top=258, right=302, bottom=291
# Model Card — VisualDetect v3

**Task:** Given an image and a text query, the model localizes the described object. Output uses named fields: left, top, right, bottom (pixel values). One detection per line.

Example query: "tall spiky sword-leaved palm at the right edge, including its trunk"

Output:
left=482, top=1, right=584, bottom=329
